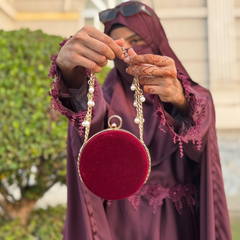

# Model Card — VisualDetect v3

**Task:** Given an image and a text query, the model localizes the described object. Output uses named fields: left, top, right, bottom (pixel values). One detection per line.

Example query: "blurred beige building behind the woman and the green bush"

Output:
left=0, top=0, right=240, bottom=217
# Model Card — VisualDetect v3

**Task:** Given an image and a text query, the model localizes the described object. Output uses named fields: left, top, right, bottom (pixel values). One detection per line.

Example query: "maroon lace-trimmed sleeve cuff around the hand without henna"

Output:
left=48, top=40, right=100, bottom=135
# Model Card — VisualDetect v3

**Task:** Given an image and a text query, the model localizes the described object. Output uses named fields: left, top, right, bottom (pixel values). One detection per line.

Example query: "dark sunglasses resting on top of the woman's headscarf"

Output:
left=99, top=2, right=152, bottom=23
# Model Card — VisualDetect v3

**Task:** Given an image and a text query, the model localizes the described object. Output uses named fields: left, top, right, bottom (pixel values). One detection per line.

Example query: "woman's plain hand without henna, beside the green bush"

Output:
left=56, top=26, right=124, bottom=88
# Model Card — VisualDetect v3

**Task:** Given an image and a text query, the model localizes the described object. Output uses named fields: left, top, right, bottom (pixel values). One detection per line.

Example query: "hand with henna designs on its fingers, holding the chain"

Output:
left=124, top=49, right=188, bottom=115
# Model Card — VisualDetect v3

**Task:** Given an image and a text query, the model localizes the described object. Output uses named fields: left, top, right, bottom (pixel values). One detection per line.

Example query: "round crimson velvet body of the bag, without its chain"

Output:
left=78, top=129, right=151, bottom=200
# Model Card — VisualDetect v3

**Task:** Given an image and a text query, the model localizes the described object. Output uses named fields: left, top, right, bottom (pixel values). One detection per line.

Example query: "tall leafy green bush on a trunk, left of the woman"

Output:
left=0, top=29, right=67, bottom=200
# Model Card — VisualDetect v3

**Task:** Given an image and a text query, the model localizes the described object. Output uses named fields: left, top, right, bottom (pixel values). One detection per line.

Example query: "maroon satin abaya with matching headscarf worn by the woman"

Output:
left=47, top=2, right=232, bottom=240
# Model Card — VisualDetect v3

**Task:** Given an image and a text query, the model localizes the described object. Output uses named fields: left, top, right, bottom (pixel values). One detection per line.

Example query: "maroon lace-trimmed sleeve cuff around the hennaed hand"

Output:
left=150, top=73, right=207, bottom=157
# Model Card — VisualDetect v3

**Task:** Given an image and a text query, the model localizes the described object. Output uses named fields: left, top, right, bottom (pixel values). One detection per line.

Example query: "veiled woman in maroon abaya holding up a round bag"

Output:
left=50, top=1, right=232, bottom=240
